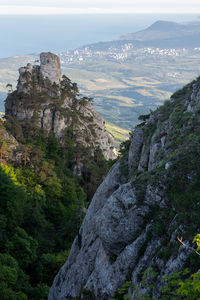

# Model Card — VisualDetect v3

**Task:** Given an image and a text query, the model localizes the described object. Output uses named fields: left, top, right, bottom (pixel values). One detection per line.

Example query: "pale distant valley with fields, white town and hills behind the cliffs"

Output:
left=0, top=22, right=200, bottom=146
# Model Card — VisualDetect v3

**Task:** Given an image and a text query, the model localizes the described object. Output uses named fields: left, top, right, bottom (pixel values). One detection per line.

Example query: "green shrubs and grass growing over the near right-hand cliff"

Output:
left=108, top=78, right=200, bottom=300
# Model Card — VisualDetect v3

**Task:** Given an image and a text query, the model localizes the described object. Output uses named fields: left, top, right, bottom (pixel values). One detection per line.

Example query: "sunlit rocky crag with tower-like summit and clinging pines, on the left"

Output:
left=5, top=52, right=116, bottom=172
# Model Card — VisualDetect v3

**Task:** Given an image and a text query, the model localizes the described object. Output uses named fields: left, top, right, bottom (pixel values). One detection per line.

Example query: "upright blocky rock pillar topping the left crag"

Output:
left=40, top=52, right=61, bottom=83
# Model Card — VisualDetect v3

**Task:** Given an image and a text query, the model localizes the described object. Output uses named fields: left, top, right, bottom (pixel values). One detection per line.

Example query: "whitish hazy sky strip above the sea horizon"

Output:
left=0, top=0, right=200, bottom=15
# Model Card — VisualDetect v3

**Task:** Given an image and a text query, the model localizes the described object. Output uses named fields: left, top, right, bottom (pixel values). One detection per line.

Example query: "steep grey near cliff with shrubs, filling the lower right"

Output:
left=49, top=79, right=200, bottom=300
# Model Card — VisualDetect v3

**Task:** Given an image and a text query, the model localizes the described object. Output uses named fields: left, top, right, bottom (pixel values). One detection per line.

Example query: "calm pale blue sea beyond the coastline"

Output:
left=0, top=14, right=198, bottom=58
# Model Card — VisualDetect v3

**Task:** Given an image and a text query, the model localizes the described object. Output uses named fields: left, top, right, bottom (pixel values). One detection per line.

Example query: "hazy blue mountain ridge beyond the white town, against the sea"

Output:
left=80, top=20, right=200, bottom=50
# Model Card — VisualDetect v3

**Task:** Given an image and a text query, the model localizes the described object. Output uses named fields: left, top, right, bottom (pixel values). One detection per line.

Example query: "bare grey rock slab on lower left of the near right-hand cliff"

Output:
left=49, top=162, right=148, bottom=299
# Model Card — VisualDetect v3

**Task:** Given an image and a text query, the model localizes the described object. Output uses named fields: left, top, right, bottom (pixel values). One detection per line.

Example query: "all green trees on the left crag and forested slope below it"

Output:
left=0, top=55, right=115, bottom=300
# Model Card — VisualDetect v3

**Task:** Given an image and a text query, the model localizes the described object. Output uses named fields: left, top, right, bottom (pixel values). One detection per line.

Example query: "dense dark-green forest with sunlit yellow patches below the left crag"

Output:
left=0, top=112, right=111, bottom=300
